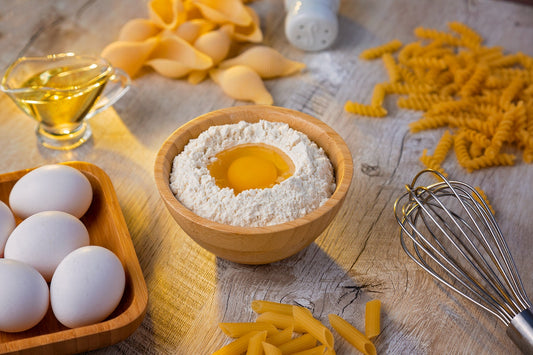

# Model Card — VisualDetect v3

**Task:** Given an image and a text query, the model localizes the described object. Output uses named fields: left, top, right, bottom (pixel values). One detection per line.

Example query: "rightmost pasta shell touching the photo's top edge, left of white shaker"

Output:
left=192, top=0, right=252, bottom=26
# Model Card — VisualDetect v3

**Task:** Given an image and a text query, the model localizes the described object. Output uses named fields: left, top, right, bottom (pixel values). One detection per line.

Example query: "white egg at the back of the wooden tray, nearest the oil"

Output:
left=9, top=164, right=93, bottom=219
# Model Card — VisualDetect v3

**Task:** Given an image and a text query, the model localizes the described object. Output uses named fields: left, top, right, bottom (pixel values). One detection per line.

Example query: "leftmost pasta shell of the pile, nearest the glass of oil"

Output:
left=101, top=37, right=158, bottom=77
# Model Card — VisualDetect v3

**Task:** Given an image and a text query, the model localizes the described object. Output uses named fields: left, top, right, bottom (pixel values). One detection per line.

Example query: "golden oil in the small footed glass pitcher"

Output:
left=14, top=64, right=110, bottom=135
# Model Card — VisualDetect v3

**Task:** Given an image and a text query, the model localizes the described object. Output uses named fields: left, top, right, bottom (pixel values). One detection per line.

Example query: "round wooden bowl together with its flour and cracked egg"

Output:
left=154, top=105, right=353, bottom=264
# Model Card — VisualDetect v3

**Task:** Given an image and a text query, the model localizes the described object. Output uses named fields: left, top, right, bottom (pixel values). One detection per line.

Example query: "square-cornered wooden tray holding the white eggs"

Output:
left=0, top=162, right=148, bottom=354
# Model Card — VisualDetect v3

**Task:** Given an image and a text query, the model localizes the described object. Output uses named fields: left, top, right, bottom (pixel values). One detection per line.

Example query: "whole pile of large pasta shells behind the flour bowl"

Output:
left=101, top=0, right=305, bottom=103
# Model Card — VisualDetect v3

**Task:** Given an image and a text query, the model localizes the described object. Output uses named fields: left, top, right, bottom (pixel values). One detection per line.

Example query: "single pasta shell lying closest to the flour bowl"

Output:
left=209, top=65, right=274, bottom=105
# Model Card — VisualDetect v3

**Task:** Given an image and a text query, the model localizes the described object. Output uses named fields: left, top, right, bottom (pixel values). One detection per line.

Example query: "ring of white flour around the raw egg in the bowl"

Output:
left=170, top=121, right=335, bottom=227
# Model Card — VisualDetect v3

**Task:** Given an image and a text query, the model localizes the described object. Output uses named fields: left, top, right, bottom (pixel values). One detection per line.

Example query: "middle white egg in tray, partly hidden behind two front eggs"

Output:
left=4, top=211, right=90, bottom=281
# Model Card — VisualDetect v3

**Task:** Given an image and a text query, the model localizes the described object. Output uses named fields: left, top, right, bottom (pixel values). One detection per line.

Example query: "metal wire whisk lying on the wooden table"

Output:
left=394, top=169, right=533, bottom=354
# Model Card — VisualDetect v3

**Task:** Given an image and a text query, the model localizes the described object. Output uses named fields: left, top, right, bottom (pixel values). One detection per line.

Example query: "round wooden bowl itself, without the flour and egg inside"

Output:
left=154, top=106, right=353, bottom=264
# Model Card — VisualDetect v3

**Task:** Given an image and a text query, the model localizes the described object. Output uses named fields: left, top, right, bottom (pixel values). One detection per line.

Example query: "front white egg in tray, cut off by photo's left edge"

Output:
left=0, top=259, right=50, bottom=332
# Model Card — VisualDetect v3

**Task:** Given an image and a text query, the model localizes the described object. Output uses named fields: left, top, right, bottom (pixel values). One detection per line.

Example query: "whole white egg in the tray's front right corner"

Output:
left=50, top=245, right=126, bottom=328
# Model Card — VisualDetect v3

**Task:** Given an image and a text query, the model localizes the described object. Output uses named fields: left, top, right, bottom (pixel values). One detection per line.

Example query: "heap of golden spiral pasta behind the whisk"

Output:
left=345, top=22, right=533, bottom=172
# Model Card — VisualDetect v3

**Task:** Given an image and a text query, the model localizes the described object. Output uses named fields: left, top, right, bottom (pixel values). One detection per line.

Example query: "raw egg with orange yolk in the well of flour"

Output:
left=208, top=144, right=294, bottom=194
